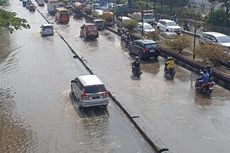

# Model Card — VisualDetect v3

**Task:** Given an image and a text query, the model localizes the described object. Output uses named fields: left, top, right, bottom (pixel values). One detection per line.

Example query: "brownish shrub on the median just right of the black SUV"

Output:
left=166, top=36, right=191, bottom=53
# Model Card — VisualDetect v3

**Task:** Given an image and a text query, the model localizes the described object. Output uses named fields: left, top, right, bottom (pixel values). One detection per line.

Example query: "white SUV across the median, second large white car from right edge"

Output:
left=156, top=19, right=182, bottom=35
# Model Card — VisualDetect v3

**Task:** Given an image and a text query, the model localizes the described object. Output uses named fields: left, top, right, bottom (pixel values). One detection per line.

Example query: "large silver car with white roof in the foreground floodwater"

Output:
left=71, top=75, right=109, bottom=108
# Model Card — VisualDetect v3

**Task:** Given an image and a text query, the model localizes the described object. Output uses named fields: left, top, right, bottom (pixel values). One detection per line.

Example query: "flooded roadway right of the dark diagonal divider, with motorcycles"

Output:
left=38, top=12, right=230, bottom=153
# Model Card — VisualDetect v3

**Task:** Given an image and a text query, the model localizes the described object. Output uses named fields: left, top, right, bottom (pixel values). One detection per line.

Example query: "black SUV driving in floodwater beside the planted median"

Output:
left=128, top=39, right=160, bottom=59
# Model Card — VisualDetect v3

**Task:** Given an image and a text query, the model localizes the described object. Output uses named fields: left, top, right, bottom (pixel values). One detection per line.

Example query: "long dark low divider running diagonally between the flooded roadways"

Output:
left=37, top=10, right=169, bottom=153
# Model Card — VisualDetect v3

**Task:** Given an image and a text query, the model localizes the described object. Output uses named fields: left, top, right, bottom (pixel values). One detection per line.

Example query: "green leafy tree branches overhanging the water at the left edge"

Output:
left=0, top=9, right=30, bottom=33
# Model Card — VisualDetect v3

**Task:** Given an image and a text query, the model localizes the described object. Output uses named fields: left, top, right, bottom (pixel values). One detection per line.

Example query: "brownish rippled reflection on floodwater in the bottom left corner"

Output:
left=0, top=83, right=36, bottom=153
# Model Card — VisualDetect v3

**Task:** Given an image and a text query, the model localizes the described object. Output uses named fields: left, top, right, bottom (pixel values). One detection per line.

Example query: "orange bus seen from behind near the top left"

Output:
left=55, top=7, right=69, bottom=24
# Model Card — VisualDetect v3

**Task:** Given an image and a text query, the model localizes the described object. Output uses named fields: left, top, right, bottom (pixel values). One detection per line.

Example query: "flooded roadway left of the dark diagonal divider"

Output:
left=0, top=0, right=153, bottom=153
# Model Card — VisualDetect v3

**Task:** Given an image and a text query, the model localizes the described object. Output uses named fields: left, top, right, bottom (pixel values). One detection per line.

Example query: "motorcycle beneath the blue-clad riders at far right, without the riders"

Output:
left=195, top=80, right=215, bottom=96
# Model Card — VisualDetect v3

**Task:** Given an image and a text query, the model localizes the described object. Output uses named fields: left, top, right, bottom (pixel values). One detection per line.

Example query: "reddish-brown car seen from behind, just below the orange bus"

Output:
left=80, top=23, right=99, bottom=39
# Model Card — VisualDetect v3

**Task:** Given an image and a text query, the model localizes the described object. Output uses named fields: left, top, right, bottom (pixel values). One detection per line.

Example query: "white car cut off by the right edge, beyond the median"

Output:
left=199, top=32, right=230, bottom=50
